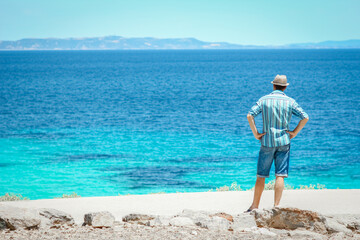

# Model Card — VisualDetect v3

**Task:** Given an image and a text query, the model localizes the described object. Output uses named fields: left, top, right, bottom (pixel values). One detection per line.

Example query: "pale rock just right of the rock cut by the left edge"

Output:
left=39, top=208, right=75, bottom=228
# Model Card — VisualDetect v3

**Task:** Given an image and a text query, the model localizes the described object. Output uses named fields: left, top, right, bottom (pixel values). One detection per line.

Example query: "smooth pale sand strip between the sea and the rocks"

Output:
left=0, top=189, right=360, bottom=224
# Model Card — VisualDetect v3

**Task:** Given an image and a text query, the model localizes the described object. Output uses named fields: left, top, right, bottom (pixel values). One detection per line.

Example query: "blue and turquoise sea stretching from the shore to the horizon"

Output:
left=0, top=50, right=360, bottom=199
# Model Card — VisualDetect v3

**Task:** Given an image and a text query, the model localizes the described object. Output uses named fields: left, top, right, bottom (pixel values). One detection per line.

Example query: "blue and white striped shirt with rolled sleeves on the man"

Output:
left=249, top=90, right=308, bottom=147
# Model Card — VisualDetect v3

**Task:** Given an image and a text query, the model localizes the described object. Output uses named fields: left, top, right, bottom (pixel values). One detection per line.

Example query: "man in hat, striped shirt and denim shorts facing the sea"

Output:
left=246, top=75, right=309, bottom=212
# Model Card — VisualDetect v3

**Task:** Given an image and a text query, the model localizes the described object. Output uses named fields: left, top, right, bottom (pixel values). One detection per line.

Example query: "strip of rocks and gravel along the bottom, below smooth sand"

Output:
left=0, top=205, right=360, bottom=239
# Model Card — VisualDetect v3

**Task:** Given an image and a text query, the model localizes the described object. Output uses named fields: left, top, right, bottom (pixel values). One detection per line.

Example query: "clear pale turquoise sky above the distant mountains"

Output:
left=0, top=0, right=360, bottom=45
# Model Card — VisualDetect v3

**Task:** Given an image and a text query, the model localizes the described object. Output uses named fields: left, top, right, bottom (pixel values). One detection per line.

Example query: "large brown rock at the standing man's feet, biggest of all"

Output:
left=252, top=208, right=327, bottom=233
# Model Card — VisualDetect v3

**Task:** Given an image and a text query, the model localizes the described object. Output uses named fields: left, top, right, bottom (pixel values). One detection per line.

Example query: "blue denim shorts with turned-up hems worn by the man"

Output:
left=257, top=144, right=290, bottom=178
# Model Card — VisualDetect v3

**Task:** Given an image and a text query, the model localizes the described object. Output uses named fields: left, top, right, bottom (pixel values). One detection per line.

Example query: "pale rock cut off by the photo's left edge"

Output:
left=0, top=205, right=41, bottom=230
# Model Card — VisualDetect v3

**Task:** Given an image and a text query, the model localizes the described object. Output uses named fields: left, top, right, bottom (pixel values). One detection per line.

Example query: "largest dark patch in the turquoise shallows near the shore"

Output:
left=102, top=166, right=219, bottom=189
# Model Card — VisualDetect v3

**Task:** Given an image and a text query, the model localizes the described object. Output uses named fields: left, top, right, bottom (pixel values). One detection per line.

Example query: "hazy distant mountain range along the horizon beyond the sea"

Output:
left=0, top=36, right=360, bottom=50
